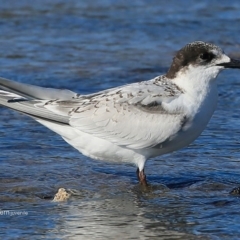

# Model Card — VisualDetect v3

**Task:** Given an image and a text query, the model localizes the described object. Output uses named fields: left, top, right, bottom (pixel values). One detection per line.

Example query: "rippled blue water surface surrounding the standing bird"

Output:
left=0, top=0, right=240, bottom=239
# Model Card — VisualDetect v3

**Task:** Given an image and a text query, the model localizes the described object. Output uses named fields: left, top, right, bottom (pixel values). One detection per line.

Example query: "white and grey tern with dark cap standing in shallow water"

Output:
left=0, top=41, right=240, bottom=186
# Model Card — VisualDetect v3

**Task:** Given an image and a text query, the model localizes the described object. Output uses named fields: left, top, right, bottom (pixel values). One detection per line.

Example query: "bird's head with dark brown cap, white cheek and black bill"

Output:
left=166, top=41, right=240, bottom=81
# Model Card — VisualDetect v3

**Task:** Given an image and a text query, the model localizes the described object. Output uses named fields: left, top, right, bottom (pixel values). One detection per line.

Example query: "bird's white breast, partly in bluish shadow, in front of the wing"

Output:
left=152, top=75, right=218, bottom=157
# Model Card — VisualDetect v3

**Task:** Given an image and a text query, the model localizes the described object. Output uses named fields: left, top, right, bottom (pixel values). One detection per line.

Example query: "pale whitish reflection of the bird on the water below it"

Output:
left=56, top=187, right=197, bottom=239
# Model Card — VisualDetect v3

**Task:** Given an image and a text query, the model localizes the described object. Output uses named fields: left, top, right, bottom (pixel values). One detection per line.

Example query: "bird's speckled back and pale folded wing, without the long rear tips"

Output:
left=45, top=80, right=185, bottom=149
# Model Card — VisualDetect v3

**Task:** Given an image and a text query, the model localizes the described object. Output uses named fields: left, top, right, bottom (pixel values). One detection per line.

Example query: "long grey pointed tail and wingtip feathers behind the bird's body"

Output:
left=0, top=78, right=77, bottom=124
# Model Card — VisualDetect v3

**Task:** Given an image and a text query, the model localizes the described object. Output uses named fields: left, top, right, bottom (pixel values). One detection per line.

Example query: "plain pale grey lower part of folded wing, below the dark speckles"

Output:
left=70, top=103, right=184, bottom=149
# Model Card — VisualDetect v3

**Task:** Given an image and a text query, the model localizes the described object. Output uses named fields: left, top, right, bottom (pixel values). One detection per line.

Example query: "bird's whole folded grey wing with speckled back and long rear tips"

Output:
left=0, top=76, right=185, bottom=149
